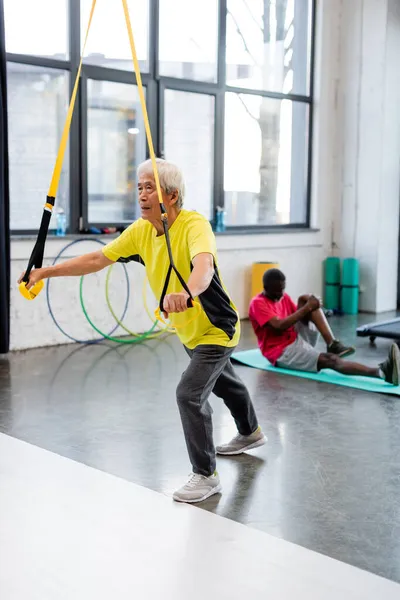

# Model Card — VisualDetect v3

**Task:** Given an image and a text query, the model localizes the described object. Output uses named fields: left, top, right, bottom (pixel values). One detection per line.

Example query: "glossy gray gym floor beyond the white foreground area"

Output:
left=0, top=315, right=400, bottom=600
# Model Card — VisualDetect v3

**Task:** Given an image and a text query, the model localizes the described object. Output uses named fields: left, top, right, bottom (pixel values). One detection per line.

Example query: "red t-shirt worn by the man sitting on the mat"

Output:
left=249, top=294, right=297, bottom=365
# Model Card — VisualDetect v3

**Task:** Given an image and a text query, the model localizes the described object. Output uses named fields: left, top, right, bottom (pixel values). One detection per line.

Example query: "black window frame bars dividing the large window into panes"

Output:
left=6, top=0, right=317, bottom=236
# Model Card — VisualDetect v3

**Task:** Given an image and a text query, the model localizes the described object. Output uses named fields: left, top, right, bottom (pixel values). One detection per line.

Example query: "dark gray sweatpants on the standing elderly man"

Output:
left=176, top=345, right=258, bottom=476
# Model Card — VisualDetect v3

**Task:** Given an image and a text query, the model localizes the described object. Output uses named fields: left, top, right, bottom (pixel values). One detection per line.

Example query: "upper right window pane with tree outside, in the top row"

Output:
left=226, top=0, right=311, bottom=95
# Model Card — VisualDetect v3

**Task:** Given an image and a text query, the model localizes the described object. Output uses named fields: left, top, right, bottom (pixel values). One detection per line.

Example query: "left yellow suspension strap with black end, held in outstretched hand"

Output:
left=19, top=0, right=96, bottom=300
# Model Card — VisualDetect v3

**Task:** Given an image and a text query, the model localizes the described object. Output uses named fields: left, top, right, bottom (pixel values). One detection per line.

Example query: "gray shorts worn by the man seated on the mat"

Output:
left=276, top=322, right=321, bottom=373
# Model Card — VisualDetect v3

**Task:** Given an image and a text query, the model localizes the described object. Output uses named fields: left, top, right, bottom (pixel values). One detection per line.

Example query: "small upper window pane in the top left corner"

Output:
left=3, top=0, right=68, bottom=59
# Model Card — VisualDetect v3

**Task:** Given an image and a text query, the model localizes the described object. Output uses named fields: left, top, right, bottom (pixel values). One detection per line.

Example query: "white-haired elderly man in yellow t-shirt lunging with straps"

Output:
left=20, top=159, right=266, bottom=502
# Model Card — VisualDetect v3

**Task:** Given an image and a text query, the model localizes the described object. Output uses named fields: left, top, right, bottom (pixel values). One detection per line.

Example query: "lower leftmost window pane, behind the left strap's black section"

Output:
left=7, top=63, right=69, bottom=230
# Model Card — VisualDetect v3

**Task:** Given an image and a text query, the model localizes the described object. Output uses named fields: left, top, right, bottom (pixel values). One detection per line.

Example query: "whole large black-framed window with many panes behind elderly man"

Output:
left=4, top=0, right=315, bottom=233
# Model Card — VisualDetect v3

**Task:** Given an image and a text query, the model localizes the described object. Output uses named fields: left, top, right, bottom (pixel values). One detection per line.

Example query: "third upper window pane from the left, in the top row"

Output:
left=160, top=0, right=218, bottom=82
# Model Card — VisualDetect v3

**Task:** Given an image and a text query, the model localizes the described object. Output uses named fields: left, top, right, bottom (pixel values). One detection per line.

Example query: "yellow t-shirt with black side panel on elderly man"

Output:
left=103, top=210, right=240, bottom=350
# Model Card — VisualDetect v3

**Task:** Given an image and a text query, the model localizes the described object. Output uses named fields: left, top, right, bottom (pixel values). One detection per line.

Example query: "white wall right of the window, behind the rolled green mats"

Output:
left=334, top=0, right=400, bottom=312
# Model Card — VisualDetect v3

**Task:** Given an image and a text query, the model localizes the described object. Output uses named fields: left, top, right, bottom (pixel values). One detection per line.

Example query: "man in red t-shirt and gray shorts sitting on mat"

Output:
left=249, top=269, right=400, bottom=385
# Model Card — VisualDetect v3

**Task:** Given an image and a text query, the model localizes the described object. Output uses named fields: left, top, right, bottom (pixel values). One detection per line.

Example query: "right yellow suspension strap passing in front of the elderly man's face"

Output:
left=122, top=0, right=200, bottom=326
